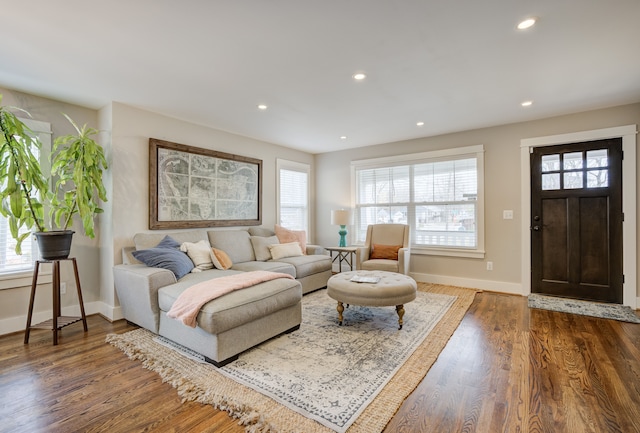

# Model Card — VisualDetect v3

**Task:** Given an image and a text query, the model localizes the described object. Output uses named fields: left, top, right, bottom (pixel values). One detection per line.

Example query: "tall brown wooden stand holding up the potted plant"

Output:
left=24, top=258, right=88, bottom=346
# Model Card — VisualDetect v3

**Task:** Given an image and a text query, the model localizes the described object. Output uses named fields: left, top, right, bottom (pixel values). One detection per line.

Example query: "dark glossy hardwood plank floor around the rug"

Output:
left=0, top=292, right=640, bottom=433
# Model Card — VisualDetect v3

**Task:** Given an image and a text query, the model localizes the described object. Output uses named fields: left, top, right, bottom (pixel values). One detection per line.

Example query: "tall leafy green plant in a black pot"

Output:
left=0, top=96, right=107, bottom=260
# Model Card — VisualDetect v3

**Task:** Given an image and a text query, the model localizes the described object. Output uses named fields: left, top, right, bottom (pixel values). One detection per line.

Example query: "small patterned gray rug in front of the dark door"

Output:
left=528, top=293, right=640, bottom=323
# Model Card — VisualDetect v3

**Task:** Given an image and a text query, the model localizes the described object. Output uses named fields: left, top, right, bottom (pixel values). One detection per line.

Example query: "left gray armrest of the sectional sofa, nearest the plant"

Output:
left=113, top=265, right=177, bottom=334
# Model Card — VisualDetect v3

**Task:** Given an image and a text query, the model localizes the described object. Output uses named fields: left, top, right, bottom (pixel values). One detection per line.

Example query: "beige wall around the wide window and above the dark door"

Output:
left=316, top=104, right=640, bottom=295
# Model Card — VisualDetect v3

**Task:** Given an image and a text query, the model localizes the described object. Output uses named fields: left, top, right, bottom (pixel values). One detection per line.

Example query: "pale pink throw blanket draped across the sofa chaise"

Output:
left=167, top=271, right=294, bottom=328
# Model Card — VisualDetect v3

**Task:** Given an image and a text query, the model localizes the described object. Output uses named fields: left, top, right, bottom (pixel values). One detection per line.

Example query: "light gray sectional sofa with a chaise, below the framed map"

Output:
left=114, top=227, right=331, bottom=366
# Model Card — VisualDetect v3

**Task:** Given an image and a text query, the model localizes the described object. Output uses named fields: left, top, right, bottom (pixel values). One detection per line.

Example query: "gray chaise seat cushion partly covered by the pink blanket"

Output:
left=158, top=271, right=302, bottom=334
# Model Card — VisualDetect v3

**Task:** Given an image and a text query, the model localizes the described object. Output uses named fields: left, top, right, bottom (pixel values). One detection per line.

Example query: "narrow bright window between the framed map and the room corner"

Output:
left=276, top=159, right=310, bottom=235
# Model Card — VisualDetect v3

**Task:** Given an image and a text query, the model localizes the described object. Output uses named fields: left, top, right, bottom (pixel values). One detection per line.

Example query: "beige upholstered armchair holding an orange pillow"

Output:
left=356, top=224, right=411, bottom=275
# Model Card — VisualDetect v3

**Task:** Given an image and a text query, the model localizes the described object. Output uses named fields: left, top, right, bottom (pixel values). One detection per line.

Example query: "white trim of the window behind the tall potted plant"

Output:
left=0, top=118, right=53, bottom=290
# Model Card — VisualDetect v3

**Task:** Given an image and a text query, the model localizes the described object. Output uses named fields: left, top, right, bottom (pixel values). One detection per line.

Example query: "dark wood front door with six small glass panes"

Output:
left=531, top=139, right=623, bottom=304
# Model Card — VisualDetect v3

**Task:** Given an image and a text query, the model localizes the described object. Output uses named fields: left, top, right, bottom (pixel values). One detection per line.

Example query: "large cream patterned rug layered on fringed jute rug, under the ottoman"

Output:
left=107, top=283, right=475, bottom=433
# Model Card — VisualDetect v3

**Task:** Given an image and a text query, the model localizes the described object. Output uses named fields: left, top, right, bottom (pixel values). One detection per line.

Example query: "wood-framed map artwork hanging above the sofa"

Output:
left=149, top=138, right=262, bottom=229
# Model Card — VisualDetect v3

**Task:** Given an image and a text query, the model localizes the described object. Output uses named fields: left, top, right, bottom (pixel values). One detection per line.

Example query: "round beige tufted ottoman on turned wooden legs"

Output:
left=327, top=271, right=417, bottom=329
